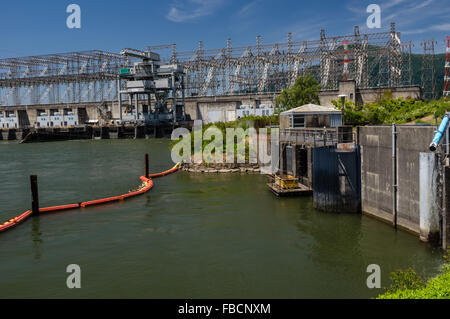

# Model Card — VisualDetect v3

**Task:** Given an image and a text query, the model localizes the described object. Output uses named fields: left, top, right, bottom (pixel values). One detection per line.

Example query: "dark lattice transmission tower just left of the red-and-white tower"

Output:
left=422, top=39, right=436, bottom=100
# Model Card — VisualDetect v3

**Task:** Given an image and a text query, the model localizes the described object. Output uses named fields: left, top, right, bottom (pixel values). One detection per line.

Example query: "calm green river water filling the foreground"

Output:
left=0, top=140, right=442, bottom=298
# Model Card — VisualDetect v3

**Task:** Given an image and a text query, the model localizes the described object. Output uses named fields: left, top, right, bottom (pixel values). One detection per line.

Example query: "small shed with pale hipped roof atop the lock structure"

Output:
left=280, top=104, right=343, bottom=129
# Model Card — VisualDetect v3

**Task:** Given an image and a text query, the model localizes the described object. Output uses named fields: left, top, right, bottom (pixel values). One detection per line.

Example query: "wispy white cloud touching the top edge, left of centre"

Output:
left=166, top=0, right=223, bottom=22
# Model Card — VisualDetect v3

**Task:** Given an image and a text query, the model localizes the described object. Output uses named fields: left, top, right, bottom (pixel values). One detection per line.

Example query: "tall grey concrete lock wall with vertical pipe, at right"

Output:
left=358, top=126, right=442, bottom=234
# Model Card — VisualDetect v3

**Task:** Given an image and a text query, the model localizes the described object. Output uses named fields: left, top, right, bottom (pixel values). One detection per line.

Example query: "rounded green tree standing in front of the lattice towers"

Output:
left=275, top=74, right=321, bottom=111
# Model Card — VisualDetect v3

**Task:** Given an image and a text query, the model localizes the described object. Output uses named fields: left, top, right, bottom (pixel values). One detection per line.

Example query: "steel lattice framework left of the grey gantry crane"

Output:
left=0, top=50, right=130, bottom=106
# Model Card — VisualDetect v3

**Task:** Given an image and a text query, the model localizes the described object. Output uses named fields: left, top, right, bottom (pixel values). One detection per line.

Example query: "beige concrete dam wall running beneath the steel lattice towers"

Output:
left=0, top=85, right=421, bottom=128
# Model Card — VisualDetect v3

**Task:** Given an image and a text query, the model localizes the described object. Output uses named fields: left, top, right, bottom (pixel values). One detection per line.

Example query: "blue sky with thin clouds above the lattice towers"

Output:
left=0, top=0, right=450, bottom=58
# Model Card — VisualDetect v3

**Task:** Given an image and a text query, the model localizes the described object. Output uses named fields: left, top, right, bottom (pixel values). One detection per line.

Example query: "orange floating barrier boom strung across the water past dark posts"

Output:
left=0, top=163, right=181, bottom=233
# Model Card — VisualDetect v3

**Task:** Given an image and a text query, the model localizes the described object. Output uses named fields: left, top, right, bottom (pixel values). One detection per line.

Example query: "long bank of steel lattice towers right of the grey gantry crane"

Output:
left=150, top=24, right=413, bottom=96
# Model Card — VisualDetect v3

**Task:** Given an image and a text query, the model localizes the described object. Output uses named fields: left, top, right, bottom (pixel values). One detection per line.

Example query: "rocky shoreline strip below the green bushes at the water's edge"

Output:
left=181, top=163, right=261, bottom=174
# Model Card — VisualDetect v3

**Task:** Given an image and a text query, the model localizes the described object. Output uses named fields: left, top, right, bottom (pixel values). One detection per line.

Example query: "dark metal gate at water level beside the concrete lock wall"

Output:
left=312, top=147, right=361, bottom=213
